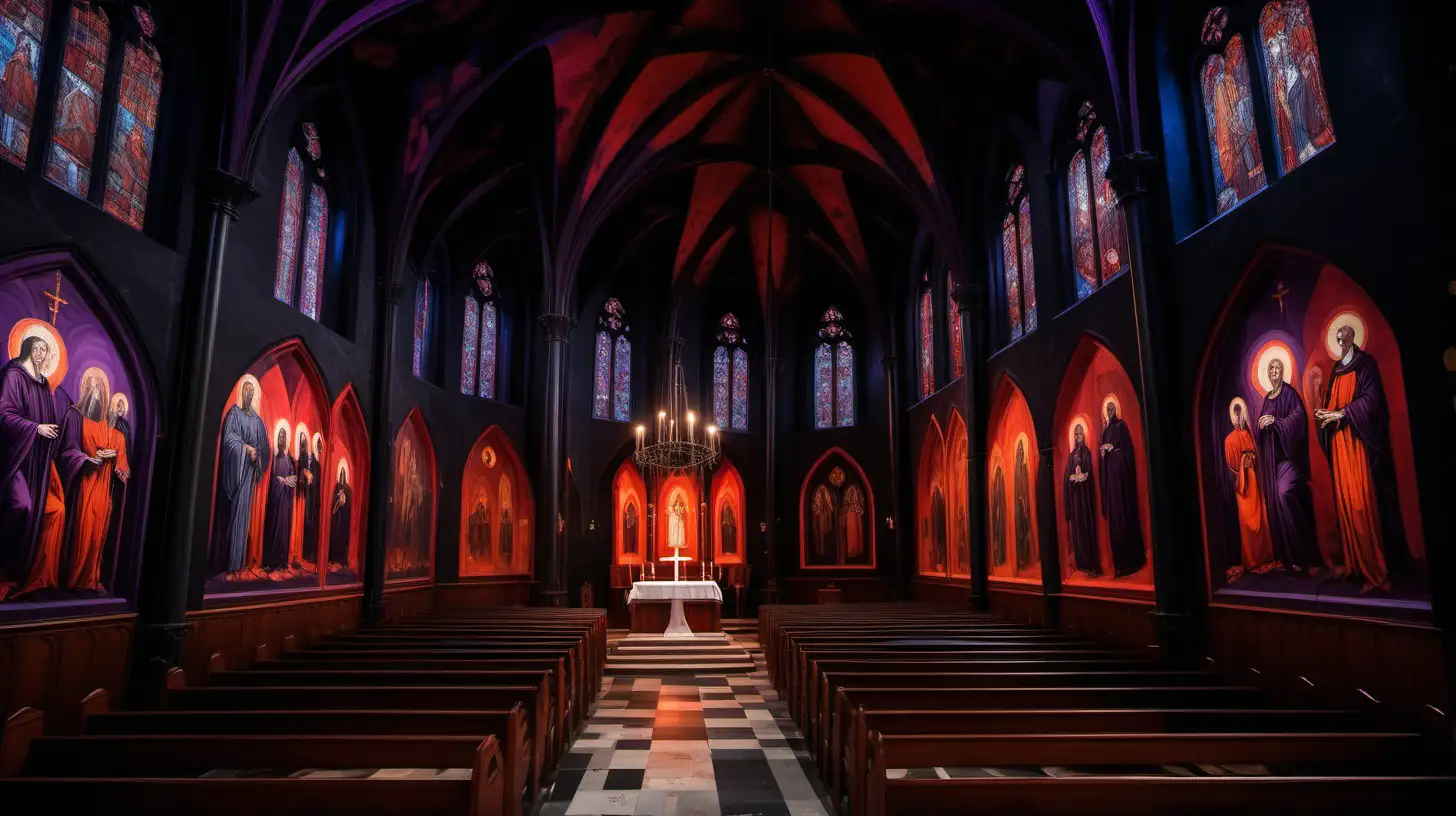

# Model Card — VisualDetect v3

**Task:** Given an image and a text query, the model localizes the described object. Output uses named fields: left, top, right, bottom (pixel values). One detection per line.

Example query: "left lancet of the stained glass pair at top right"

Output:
left=1203, top=34, right=1264, bottom=213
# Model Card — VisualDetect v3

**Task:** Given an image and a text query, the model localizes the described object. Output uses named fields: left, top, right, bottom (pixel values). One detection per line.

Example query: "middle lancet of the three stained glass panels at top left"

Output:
left=45, top=3, right=111, bottom=198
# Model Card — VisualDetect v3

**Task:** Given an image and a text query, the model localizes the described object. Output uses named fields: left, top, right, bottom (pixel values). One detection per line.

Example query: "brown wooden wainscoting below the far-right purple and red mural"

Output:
left=1208, top=605, right=1450, bottom=715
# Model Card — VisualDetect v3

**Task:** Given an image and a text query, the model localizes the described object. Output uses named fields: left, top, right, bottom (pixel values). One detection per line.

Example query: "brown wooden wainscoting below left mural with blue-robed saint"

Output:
left=182, top=587, right=362, bottom=685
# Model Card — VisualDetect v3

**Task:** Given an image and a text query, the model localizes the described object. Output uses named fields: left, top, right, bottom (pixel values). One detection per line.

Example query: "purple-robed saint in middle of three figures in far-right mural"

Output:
left=1254, top=360, right=1325, bottom=571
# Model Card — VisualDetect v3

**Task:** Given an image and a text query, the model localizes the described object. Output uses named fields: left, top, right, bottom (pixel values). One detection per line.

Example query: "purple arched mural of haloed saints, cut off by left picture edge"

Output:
left=0, top=254, right=154, bottom=619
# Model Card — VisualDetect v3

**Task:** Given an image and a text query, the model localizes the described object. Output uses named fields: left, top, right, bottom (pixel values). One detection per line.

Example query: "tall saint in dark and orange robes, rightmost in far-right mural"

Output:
left=1315, top=325, right=1406, bottom=592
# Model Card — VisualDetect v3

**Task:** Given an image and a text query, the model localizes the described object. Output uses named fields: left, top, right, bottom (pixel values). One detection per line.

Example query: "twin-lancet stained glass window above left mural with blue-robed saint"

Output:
left=274, top=122, right=329, bottom=321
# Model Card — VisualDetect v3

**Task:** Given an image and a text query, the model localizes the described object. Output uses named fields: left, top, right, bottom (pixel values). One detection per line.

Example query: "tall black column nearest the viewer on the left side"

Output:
left=132, top=169, right=258, bottom=701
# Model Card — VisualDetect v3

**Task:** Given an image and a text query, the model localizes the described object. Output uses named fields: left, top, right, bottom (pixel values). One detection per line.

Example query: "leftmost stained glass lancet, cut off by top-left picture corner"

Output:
left=0, top=0, right=51, bottom=168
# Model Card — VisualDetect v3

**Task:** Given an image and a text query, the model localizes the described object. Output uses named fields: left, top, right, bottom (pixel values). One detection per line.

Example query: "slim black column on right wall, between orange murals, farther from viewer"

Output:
left=951, top=284, right=990, bottom=612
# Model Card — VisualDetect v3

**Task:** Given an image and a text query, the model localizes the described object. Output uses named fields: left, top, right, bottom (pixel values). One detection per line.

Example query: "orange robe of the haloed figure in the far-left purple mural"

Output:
left=66, top=412, right=131, bottom=590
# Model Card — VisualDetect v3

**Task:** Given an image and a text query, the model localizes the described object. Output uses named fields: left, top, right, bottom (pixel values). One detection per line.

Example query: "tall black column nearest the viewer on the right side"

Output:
left=1108, top=152, right=1197, bottom=666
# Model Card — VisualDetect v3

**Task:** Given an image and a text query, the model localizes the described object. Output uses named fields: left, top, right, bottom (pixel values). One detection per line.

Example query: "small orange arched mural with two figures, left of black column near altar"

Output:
left=460, top=425, right=536, bottom=578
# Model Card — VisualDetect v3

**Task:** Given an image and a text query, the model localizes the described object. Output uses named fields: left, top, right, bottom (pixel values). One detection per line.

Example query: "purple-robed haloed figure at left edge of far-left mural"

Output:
left=0, top=337, right=61, bottom=583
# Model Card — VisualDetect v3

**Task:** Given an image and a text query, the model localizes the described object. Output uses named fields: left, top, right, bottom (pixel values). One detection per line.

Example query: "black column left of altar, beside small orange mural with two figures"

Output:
left=536, top=313, right=577, bottom=606
